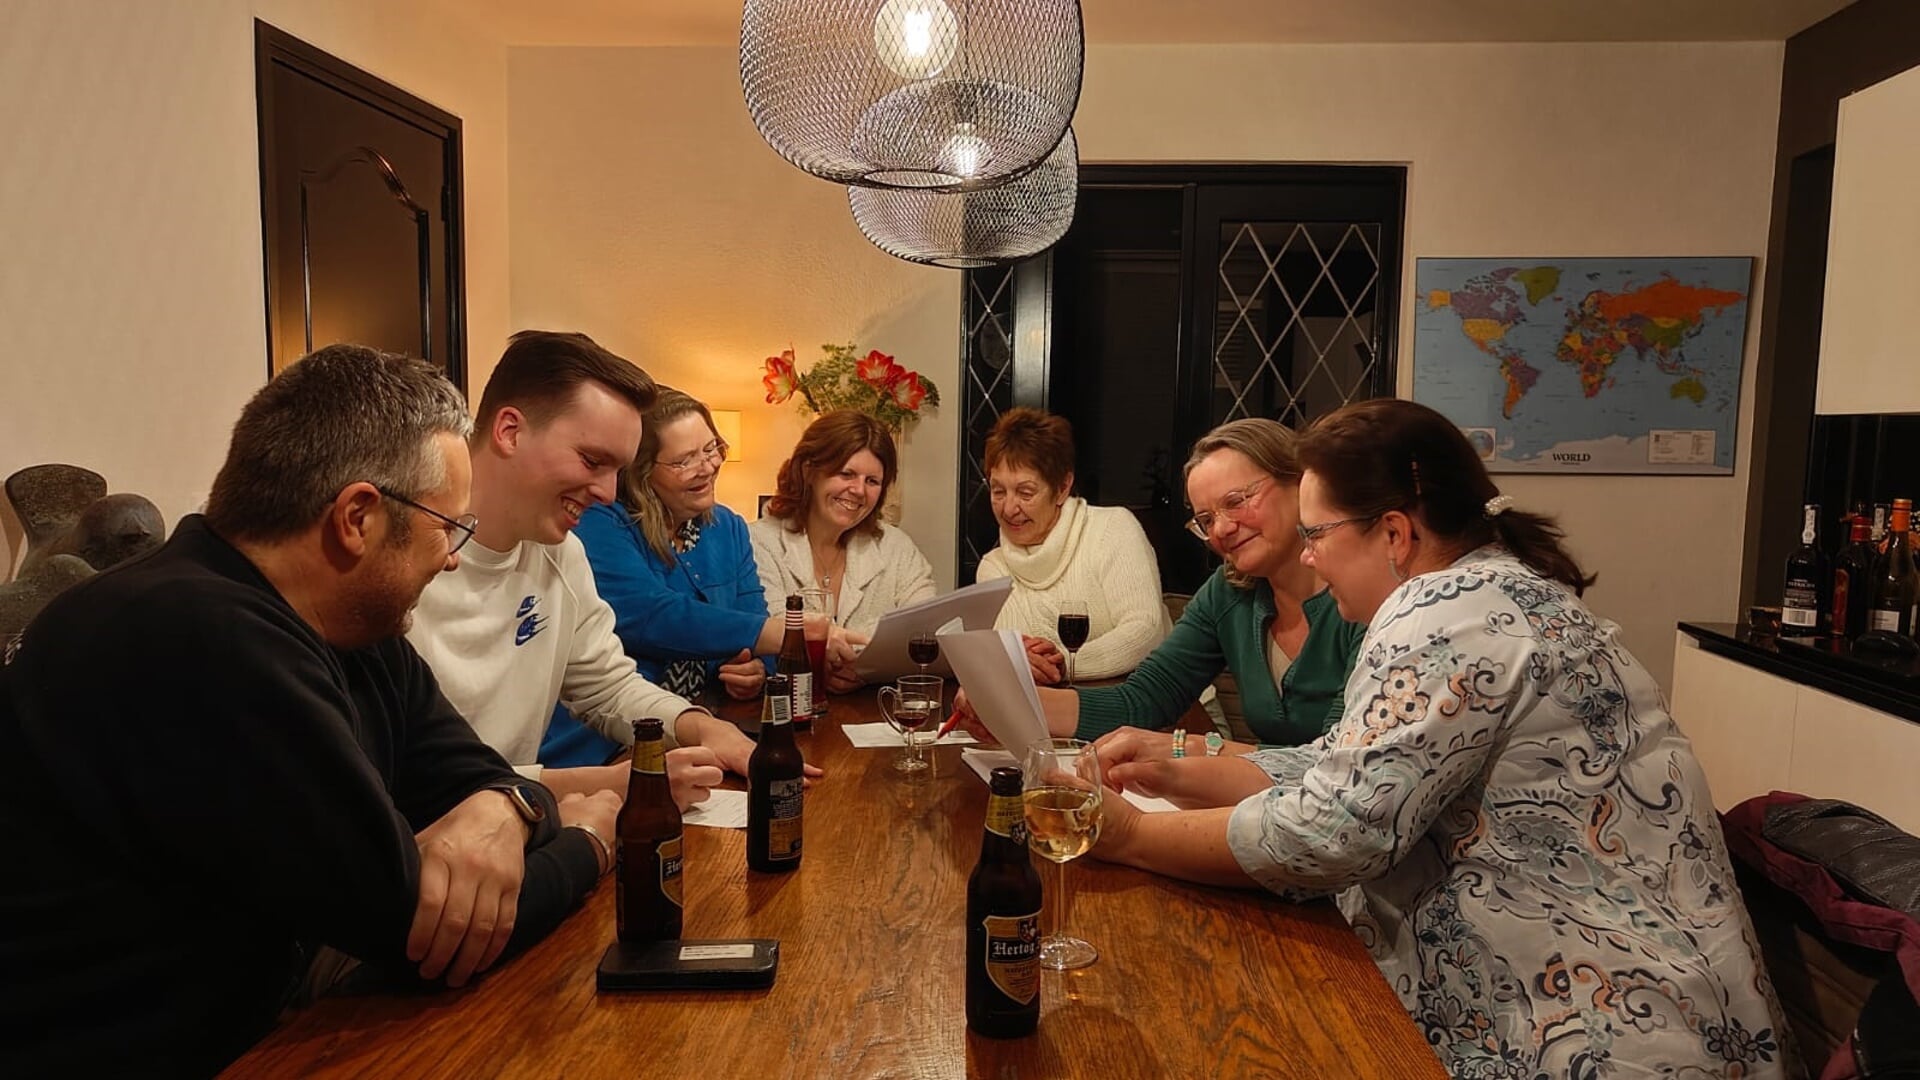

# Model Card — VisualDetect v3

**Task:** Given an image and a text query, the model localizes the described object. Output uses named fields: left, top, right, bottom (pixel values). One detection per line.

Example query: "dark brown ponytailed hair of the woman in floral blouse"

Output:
left=1300, top=398, right=1596, bottom=596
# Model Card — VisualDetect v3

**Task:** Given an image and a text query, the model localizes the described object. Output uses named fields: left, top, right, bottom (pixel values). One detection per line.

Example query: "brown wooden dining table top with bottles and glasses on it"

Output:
left=227, top=692, right=1444, bottom=1080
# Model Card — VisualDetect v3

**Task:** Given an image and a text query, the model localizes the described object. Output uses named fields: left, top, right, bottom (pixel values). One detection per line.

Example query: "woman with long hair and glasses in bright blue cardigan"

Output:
left=540, top=386, right=785, bottom=767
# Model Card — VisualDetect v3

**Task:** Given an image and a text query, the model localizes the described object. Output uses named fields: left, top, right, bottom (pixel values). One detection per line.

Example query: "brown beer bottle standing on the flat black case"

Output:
left=612, top=721, right=684, bottom=944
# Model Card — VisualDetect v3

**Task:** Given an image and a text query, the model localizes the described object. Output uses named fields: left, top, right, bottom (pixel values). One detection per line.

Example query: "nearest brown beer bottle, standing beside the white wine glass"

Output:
left=966, top=767, right=1041, bottom=1040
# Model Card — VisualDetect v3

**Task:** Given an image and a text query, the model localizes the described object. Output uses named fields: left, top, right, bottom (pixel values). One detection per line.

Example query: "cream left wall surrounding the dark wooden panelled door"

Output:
left=0, top=0, right=507, bottom=580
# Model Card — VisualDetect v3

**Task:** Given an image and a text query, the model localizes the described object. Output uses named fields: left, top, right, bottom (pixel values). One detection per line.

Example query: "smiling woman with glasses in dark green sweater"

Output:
left=956, top=419, right=1367, bottom=755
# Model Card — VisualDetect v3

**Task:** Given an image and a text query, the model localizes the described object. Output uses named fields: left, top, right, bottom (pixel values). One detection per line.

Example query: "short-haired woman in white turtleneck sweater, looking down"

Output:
left=975, top=409, right=1169, bottom=682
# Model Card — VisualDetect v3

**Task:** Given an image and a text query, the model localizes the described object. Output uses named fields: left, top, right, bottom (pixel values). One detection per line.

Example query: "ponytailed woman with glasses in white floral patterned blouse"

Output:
left=1094, top=400, right=1797, bottom=1080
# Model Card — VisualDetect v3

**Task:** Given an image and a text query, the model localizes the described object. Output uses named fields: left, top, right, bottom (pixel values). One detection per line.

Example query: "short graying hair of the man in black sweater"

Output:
left=207, top=344, right=472, bottom=540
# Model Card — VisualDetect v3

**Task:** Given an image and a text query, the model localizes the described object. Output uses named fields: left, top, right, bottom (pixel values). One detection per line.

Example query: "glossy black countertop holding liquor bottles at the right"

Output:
left=1680, top=623, right=1920, bottom=723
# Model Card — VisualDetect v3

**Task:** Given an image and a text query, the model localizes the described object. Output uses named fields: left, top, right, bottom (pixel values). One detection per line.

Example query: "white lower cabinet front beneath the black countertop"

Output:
left=1670, top=632, right=1920, bottom=822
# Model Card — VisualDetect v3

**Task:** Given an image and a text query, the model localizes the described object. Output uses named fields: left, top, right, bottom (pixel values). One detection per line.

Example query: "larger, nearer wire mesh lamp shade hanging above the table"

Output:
left=739, top=0, right=1085, bottom=190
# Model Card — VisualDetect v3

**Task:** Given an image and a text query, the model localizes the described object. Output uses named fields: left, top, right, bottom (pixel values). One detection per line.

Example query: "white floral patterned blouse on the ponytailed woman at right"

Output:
left=1229, top=548, right=1799, bottom=1080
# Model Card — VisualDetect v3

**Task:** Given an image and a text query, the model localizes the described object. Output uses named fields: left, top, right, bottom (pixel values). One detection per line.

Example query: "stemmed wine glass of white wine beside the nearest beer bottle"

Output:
left=1020, top=738, right=1100, bottom=970
